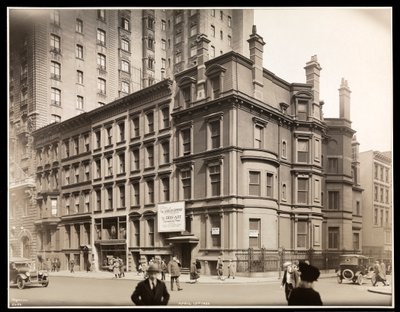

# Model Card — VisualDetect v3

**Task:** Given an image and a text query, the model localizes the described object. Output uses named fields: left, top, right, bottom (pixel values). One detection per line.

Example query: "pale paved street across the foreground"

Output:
left=9, top=277, right=391, bottom=307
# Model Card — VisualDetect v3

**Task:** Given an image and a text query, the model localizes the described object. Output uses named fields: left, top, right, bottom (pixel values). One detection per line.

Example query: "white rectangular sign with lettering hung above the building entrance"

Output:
left=157, top=201, right=186, bottom=232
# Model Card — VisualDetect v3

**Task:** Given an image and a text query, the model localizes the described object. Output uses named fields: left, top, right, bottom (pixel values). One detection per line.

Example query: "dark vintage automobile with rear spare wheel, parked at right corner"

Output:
left=336, top=254, right=369, bottom=285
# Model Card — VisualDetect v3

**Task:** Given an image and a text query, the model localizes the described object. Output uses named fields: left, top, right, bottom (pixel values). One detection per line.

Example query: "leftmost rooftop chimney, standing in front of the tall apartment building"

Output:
left=196, top=34, right=210, bottom=100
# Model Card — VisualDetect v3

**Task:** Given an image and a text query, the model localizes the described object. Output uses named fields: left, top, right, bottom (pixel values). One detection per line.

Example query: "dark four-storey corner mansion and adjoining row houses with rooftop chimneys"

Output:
left=33, top=27, right=362, bottom=274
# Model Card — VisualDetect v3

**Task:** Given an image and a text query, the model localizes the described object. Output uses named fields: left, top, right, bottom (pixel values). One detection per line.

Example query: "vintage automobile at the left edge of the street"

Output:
left=9, top=258, right=49, bottom=289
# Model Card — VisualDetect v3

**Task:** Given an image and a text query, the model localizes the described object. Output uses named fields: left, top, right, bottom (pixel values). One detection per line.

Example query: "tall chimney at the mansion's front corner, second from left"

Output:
left=247, top=25, right=265, bottom=100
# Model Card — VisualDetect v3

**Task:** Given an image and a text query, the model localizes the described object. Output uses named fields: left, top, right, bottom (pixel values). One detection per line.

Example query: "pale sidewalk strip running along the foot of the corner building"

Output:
left=49, top=271, right=336, bottom=284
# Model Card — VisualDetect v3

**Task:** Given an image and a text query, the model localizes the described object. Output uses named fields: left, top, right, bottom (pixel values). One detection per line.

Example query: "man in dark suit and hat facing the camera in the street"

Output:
left=131, top=264, right=170, bottom=305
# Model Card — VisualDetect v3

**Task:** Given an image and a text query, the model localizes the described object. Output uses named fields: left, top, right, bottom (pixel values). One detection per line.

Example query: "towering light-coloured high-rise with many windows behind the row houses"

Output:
left=9, top=9, right=253, bottom=257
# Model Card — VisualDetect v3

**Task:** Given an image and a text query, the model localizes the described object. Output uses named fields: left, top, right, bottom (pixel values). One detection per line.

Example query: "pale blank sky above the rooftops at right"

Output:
left=254, top=7, right=393, bottom=152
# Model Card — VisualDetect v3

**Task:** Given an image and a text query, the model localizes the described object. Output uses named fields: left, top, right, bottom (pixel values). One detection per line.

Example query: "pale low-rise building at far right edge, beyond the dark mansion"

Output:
left=360, top=150, right=393, bottom=258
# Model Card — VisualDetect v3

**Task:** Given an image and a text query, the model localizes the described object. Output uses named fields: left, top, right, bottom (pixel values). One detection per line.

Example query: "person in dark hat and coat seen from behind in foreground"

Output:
left=288, top=261, right=322, bottom=305
